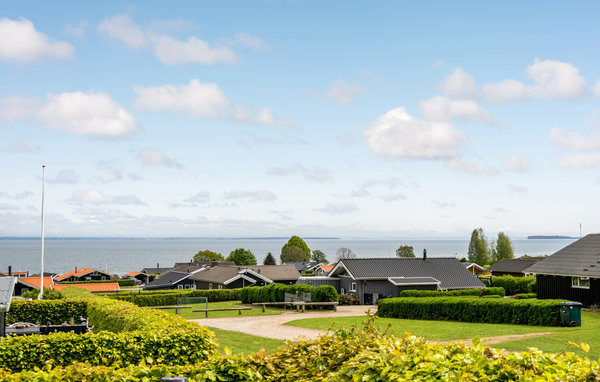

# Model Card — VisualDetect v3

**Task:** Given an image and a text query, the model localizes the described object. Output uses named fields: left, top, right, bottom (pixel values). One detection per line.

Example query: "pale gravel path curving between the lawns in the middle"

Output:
left=190, top=305, right=377, bottom=340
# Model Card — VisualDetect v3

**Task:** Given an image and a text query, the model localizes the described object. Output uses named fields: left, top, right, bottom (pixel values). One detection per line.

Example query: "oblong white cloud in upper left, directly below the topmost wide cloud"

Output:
left=134, top=79, right=231, bottom=118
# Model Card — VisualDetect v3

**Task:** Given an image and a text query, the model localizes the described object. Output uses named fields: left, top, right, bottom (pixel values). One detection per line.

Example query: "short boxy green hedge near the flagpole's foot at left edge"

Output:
left=6, top=299, right=87, bottom=325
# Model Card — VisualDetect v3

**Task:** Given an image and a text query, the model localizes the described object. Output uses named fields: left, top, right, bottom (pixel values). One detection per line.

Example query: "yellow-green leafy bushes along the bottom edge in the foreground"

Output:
left=0, top=321, right=600, bottom=382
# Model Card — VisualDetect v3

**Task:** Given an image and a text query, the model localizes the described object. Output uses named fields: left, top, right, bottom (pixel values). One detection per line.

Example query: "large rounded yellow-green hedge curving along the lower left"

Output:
left=0, top=294, right=217, bottom=372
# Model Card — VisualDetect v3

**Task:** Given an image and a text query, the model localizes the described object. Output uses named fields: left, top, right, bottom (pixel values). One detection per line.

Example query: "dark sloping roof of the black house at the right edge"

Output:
left=526, top=233, right=600, bottom=277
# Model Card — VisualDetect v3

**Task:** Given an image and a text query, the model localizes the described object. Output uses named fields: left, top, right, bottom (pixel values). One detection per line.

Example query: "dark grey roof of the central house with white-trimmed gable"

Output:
left=328, top=257, right=485, bottom=289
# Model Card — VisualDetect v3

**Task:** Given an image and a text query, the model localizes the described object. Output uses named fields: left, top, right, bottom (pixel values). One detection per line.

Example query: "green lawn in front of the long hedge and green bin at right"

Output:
left=287, top=312, right=600, bottom=359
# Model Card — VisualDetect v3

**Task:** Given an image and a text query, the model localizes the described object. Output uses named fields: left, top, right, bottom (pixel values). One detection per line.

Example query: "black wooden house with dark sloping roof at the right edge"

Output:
left=525, top=234, right=600, bottom=306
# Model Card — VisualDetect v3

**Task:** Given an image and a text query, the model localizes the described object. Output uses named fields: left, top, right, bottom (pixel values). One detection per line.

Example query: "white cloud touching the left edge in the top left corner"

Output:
left=0, top=18, right=73, bottom=62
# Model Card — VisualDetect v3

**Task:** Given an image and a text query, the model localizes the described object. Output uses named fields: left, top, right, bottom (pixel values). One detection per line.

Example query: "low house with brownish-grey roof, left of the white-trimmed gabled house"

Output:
left=190, top=264, right=300, bottom=289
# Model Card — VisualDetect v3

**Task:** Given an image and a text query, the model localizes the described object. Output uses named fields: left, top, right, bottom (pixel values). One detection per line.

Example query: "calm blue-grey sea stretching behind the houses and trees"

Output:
left=0, top=239, right=574, bottom=275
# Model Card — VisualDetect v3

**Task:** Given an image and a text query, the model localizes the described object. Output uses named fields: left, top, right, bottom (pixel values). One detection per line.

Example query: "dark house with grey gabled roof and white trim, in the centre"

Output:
left=298, top=257, right=485, bottom=305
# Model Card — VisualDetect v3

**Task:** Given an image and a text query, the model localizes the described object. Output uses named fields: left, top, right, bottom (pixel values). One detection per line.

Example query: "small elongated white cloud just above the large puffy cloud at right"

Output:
left=419, top=96, right=494, bottom=123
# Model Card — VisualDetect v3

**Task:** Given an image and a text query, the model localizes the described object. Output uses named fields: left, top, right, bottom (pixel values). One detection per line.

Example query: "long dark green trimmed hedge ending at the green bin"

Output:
left=377, top=297, right=564, bottom=326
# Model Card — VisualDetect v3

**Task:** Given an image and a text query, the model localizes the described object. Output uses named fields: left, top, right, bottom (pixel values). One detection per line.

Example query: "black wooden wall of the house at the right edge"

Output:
left=536, top=274, right=600, bottom=306
